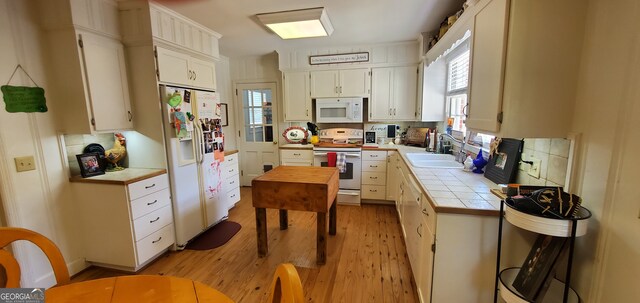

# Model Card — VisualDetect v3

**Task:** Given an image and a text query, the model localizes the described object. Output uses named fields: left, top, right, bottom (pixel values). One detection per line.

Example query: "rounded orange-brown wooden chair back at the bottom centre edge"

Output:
left=268, top=263, right=304, bottom=303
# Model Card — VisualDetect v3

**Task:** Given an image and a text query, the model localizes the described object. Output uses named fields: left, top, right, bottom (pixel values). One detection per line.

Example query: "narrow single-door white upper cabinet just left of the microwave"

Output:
left=282, top=72, right=312, bottom=121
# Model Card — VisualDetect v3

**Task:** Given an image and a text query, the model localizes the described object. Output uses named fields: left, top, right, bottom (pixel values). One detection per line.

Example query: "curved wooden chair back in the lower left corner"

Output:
left=0, top=227, right=69, bottom=288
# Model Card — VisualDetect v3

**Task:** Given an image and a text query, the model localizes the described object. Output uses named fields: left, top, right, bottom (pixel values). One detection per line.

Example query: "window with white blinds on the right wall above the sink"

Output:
left=445, top=43, right=469, bottom=133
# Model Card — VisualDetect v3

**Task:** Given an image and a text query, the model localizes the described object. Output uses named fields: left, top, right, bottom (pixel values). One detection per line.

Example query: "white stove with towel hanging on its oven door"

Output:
left=313, top=128, right=364, bottom=205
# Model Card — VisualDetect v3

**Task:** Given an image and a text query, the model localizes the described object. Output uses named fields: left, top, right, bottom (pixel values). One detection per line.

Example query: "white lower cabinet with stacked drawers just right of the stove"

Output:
left=361, top=150, right=387, bottom=200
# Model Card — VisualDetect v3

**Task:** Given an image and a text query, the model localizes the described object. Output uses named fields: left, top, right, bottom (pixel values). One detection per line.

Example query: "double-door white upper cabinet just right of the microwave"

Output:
left=369, top=65, right=418, bottom=121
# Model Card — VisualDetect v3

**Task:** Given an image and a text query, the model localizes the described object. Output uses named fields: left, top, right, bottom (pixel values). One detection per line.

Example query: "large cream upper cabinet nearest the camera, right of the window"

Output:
left=465, top=0, right=586, bottom=138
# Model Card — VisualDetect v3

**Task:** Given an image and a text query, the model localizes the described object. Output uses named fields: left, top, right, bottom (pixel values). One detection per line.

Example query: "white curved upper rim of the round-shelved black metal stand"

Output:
left=502, top=200, right=591, bottom=237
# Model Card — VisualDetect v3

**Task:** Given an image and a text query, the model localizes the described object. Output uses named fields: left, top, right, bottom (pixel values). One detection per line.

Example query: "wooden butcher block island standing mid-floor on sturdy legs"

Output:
left=251, top=166, right=339, bottom=264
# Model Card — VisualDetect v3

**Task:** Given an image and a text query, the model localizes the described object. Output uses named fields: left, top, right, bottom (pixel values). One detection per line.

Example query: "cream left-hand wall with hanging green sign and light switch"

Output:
left=0, top=0, right=86, bottom=287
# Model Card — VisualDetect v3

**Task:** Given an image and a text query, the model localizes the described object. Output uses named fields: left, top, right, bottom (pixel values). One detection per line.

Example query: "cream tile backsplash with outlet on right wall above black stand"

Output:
left=516, top=138, right=571, bottom=186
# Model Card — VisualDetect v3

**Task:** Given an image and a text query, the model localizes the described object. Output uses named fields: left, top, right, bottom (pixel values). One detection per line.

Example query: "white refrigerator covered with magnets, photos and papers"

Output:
left=160, top=86, right=229, bottom=249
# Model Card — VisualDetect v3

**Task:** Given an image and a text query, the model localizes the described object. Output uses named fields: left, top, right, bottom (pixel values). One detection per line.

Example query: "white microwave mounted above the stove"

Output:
left=316, top=98, right=363, bottom=123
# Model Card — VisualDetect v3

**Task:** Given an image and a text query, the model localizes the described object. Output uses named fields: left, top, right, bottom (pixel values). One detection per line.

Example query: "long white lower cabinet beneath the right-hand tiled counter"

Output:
left=396, top=159, right=512, bottom=303
